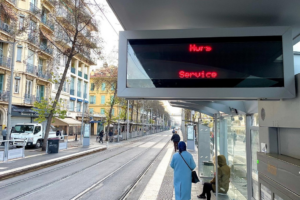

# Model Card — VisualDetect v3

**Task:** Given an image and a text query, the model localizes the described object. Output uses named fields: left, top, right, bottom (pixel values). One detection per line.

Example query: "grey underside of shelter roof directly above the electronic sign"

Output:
left=107, top=0, right=300, bottom=43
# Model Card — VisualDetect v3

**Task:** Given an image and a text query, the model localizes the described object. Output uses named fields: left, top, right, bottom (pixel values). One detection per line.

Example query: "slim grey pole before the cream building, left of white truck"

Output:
left=7, top=42, right=15, bottom=140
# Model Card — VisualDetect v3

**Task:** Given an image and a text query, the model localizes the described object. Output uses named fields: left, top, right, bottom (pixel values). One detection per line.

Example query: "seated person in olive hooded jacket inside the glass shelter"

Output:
left=197, top=155, right=230, bottom=200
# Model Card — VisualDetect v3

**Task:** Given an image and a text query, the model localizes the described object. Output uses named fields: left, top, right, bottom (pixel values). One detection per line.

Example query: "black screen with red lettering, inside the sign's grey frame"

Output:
left=127, top=36, right=284, bottom=88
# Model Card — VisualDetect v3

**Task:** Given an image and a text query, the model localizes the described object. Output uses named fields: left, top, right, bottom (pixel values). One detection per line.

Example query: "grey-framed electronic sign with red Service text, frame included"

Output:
left=118, top=27, right=295, bottom=99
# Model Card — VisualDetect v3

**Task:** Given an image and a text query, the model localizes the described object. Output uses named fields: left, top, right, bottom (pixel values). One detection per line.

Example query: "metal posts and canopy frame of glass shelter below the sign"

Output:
left=169, top=100, right=258, bottom=200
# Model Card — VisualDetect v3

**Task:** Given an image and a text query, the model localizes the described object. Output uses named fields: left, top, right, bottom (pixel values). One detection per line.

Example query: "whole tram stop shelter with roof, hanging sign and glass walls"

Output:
left=107, top=0, right=300, bottom=200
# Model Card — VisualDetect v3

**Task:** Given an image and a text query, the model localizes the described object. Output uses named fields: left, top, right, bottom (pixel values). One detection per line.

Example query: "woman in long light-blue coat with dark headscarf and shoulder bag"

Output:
left=171, top=141, right=196, bottom=200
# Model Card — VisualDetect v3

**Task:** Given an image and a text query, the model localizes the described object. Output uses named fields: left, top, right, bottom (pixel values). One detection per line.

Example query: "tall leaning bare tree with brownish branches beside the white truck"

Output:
left=29, top=0, right=103, bottom=150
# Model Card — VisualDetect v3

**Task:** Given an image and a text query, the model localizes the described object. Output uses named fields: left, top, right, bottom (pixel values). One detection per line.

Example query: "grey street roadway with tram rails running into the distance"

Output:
left=0, top=131, right=171, bottom=200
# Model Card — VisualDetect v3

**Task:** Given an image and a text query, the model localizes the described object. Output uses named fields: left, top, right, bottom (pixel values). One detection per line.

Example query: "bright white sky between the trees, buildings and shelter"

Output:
left=92, top=0, right=181, bottom=120
